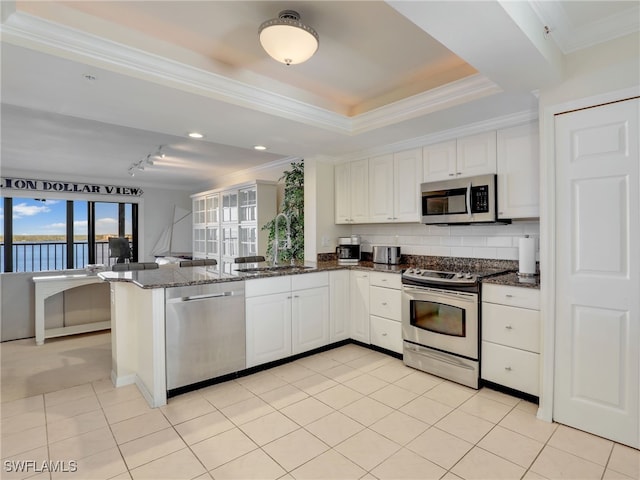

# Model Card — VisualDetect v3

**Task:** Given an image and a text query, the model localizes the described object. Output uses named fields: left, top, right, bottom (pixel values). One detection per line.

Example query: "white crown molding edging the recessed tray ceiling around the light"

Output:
left=0, top=11, right=501, bottom=135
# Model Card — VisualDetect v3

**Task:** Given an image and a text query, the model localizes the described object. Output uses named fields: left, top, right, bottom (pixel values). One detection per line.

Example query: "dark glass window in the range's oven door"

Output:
left=411, top=300, right=466, bottom=337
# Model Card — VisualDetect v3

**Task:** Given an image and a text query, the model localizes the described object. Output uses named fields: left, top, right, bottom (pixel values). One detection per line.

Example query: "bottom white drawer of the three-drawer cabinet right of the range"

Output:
left=480, top=341, right=540, bottom=396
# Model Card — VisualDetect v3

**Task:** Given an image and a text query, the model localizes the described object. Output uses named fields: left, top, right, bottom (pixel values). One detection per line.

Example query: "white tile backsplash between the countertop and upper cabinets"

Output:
left=352, top=221, right=540, bottom=260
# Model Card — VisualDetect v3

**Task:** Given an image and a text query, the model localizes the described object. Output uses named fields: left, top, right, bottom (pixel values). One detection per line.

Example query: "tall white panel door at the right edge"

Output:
left=553, top=99, right=640, bottom=448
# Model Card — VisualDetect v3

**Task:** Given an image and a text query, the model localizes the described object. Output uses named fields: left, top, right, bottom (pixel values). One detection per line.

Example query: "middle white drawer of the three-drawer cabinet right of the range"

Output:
left=482, top=302, right=540, bottom=353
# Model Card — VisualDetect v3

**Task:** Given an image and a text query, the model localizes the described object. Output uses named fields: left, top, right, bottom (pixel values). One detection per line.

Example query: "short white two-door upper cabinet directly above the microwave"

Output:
left=423, top=131, right=496, bottom=182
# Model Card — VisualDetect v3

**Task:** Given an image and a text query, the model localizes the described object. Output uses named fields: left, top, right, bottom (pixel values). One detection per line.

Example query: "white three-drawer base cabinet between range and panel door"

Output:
left=481, top=284, right=540, bottom=396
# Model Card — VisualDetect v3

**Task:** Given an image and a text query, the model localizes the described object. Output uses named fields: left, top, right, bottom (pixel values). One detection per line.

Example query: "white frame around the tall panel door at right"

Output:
left=537, top=86, right=640, bottom=422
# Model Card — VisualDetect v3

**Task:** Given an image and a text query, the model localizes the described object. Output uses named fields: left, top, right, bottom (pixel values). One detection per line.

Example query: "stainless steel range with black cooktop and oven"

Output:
left=402, top=268, right=499, bottom=388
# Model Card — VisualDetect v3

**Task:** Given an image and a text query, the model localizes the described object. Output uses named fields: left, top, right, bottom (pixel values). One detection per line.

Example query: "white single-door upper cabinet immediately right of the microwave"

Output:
left=497, top=123, right=540, bottom=219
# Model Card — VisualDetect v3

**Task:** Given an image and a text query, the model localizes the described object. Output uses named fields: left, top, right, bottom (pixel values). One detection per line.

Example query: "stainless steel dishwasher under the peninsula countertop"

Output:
left=165, top=281, right=246, bottom=392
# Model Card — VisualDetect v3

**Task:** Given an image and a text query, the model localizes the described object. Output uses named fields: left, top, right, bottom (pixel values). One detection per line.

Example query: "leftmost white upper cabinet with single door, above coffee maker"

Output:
left=334, top=159, right=369, bottom=224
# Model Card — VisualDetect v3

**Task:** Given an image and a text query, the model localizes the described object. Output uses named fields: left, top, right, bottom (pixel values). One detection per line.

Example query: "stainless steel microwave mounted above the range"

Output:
left=421, top=174, right=510, bottom=225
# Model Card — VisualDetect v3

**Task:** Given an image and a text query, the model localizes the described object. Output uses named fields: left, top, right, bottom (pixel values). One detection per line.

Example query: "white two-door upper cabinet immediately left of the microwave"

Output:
left=369, top=148, right=422, bottom=223
